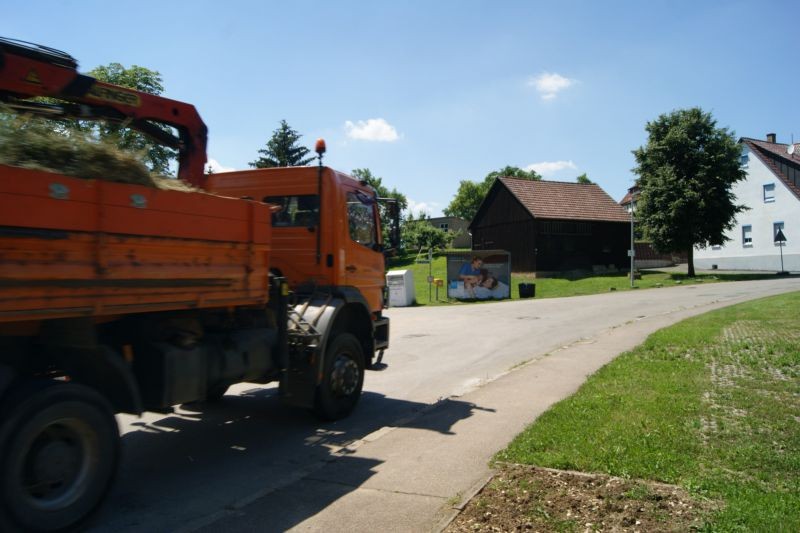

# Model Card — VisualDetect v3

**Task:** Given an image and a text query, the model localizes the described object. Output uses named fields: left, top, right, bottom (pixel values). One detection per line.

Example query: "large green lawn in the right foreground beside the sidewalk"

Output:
left=496, top=293, right=800, bottom=532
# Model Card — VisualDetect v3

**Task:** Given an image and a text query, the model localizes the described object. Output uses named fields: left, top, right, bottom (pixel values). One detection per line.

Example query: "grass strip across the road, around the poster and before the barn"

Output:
left=387, top=255, right=788, bottom=305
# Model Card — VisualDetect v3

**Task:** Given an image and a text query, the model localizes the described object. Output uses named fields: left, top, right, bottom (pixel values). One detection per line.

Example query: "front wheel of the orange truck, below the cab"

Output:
left=314, top=333, right=364, bottom=421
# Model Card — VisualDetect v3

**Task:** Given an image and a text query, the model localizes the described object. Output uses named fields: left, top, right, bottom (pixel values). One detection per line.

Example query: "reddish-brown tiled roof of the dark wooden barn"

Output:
left=500, top=178, right=630, bottom=222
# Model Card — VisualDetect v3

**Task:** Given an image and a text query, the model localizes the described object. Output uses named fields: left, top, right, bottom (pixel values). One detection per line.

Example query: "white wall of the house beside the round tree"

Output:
left=694, top=145, right=800, bottom=271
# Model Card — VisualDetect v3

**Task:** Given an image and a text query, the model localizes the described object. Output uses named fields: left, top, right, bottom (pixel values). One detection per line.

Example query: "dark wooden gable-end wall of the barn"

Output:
left=472, top=187, right=536, bottom=272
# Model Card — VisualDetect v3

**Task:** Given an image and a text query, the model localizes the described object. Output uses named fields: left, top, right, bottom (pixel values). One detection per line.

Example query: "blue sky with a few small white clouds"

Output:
left=0, top=0, right=800, bottom=216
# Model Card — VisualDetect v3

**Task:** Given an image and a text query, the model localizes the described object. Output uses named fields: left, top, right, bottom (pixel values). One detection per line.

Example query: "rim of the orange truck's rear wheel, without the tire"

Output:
left=21, top=419, right=96, bottom=510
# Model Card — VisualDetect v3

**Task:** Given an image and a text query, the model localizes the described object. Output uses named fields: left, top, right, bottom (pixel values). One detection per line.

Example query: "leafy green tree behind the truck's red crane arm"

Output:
left=76, top=63, right=178, bottom=175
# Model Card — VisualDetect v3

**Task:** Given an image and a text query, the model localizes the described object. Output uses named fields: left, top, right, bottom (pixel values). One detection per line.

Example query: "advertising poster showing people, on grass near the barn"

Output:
left=445, top=250, right=511, bottom=300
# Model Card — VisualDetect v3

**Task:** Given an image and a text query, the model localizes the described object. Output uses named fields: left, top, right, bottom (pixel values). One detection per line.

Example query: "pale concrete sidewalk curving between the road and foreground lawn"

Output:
left=197, top=301, right=780, bottom=532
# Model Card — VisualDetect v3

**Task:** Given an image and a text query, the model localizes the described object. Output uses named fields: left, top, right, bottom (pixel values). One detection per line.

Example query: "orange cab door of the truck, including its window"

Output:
left=343, top=187, right=385, bottom=311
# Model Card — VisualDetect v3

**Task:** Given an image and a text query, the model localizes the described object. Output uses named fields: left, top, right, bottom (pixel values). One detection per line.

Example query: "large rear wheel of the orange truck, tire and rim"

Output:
left=0, top=382, right=120, bottom=531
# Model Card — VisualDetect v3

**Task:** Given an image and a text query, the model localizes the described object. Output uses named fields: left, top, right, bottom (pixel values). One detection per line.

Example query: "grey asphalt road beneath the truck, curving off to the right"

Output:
left=90, top=278, right=800, bottom=532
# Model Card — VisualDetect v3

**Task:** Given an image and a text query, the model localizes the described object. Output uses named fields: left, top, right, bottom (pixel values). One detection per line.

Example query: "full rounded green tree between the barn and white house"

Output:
left=633, top=107, right=746, bottom=277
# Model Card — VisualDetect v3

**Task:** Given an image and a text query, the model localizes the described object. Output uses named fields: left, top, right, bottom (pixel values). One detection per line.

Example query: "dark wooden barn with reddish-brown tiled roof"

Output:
left=469, top=178, right=630, bottom=275
